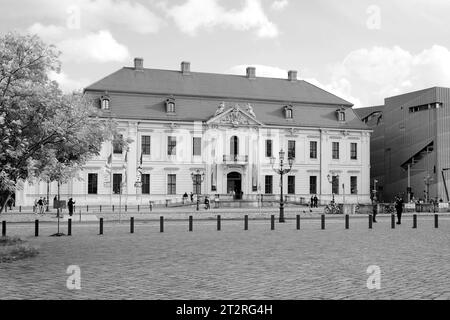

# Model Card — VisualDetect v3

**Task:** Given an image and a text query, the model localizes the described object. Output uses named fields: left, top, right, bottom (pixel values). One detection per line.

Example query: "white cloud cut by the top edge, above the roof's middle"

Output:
left=166, top=0, right=279, bottom=38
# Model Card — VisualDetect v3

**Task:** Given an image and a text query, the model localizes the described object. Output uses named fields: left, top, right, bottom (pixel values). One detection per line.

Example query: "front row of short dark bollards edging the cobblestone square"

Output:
left=2, top=214, right=439, bottom=237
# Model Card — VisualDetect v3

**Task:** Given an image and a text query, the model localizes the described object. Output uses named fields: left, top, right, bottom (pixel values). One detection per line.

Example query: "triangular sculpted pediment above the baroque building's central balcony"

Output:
left=206, top=103, right=264, bottom=127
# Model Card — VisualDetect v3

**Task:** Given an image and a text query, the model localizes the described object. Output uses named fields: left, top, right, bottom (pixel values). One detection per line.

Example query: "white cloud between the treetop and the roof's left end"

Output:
left=28, top=23, right=130, bottom=63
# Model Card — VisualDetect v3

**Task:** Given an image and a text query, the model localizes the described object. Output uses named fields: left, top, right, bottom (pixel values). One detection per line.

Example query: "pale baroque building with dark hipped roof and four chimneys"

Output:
left=16, top=58, right=371, bottom=205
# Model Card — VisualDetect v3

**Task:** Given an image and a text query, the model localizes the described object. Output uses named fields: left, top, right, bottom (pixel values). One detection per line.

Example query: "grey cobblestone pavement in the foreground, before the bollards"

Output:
left=0, top=216, right=450, bottom=299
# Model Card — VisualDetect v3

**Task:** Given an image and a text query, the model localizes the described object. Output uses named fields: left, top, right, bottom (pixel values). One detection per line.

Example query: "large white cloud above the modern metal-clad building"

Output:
left=332, top=45, right=450, bottom=106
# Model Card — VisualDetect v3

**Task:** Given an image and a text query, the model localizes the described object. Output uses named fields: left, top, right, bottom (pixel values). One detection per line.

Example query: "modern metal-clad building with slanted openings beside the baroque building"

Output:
left=355, top=87, right=450, bottom=201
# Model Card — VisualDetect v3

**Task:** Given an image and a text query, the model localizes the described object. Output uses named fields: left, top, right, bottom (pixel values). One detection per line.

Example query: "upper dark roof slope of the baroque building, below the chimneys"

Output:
left=85, top=67, right=352, bottom=106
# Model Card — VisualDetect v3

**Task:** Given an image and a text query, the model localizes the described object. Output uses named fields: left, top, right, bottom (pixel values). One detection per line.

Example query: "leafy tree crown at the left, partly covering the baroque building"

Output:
left=0, top=33, right=123, bottom=213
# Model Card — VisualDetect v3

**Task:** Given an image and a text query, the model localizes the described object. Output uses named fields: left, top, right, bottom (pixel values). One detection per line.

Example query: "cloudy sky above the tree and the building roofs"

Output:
left=0, top=0, right=450, bottom=108
